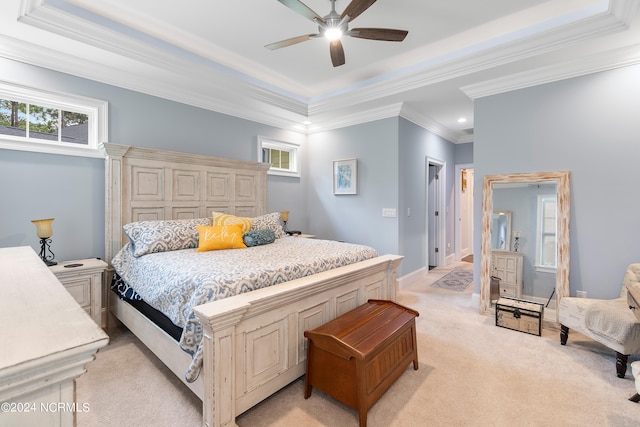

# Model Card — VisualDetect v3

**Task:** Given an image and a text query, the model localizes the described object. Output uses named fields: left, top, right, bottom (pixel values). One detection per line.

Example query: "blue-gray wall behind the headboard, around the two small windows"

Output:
left=0, top=58, right=307, bottom=260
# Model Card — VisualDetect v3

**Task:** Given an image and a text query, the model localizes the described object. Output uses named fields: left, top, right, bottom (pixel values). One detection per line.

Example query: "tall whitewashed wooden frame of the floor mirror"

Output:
left=480, top=171, right=571, bottom=322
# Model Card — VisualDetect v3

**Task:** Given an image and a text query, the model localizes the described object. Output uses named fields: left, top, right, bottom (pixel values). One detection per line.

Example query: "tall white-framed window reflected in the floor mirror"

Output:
left=536, top=195, right=558, bottom=271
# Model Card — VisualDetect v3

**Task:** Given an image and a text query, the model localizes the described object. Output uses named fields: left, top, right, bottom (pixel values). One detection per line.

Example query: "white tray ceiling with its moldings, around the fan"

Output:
left=0, top=0, right=640, bottom=142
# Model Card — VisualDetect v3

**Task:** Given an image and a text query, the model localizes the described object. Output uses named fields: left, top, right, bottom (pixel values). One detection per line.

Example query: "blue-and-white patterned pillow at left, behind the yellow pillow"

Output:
left=122, top=218, right=211, bottom=257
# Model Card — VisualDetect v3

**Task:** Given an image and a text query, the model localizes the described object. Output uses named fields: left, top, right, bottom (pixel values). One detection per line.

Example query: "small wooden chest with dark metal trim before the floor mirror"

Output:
left=496, top=297, right=544, bottom=336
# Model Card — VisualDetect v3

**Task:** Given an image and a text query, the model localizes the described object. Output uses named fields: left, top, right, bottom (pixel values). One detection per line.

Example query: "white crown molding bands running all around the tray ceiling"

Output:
left=8, top=0, right=638, bottom=142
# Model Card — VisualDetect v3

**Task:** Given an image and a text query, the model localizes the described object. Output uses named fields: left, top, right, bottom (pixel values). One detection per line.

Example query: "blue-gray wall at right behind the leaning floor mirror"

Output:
left=474, top=66, right=640, bottom=298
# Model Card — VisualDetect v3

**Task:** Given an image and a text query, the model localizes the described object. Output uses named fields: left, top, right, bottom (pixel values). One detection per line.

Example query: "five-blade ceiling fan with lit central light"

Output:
left=265, top=0, right=409, bottom=67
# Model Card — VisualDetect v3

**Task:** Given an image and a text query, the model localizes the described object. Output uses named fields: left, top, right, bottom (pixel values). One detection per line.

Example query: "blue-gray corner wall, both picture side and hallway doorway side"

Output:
left=307, top=118, right=460, bottom=276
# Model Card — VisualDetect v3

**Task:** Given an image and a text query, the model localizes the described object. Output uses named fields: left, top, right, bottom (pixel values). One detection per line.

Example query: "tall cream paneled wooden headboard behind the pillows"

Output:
left=101, top=143, right=269, bottom=264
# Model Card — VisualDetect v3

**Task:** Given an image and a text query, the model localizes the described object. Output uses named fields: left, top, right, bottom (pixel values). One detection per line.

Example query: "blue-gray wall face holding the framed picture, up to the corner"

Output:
left=305, top=118, right=399, bottom=254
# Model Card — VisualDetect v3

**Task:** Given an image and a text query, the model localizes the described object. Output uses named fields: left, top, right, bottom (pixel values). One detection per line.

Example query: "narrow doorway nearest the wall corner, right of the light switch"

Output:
left=425, top=158, right=446, bottom=270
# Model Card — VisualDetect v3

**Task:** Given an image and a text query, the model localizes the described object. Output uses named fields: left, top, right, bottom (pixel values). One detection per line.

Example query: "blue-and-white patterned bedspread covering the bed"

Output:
left=112, top=237, right=378, bottom=382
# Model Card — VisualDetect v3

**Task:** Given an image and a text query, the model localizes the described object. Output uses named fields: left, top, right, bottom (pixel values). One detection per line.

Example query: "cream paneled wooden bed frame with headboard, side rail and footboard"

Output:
left=102, top=143, right=402, bottom=426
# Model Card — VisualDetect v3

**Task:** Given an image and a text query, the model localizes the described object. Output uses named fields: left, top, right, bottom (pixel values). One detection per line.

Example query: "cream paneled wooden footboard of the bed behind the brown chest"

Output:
left=194, top=255, right=402, bottom=427
